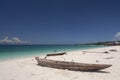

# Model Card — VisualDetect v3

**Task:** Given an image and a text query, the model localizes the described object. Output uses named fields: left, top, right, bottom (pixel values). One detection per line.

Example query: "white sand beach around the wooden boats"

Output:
left=0, top=46, right=120, bottom=80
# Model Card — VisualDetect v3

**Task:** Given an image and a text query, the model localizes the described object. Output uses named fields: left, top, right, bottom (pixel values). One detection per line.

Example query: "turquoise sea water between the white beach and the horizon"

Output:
left=0, top=45, right=104, bottom=61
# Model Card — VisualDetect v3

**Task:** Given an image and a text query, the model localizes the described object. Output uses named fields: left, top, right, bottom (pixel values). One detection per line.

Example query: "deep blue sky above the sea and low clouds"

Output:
left=0, top=0, right=120, bottom=44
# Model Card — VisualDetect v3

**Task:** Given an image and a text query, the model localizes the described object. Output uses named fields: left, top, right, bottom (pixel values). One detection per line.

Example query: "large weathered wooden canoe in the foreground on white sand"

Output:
left=35, top=57, right=112, bottom=71
